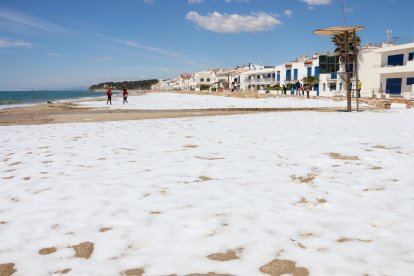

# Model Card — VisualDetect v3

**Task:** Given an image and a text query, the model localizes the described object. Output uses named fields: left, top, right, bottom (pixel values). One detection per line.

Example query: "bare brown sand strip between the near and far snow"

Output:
left=0, top=103, right=356, bottom=126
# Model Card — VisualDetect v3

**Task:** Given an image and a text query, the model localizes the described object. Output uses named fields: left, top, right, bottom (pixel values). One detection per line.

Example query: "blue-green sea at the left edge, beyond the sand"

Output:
left=0, top=90, right=112, bottom=109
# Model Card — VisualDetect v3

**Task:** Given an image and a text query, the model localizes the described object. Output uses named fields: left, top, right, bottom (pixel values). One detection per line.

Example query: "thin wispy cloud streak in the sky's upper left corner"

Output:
left=0, top=8, right=67, bottom=32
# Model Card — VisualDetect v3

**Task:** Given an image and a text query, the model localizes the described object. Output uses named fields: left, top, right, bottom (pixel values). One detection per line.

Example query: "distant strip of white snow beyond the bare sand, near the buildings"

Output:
left=79, top=93, right=368, bottom=109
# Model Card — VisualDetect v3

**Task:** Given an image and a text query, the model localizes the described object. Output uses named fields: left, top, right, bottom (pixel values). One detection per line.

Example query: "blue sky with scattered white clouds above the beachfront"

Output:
left=0, top=0, right=414, bottom=90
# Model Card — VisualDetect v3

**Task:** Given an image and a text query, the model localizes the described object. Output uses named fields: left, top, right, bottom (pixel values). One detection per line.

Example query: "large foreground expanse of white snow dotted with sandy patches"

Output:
left=0, top=94, right=414, bottom=276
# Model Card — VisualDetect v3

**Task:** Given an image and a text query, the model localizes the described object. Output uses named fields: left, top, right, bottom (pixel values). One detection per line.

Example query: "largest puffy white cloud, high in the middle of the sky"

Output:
left=186, top=11, right=281, bottom=33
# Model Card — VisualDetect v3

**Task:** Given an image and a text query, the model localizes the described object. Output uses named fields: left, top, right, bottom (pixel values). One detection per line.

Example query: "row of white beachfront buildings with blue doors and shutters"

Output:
left=154, top=40, right=414, bottom=97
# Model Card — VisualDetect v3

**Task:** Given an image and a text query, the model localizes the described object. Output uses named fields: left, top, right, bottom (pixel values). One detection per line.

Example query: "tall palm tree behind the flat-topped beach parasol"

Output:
left=331, top=32, right=361, bottom=111
